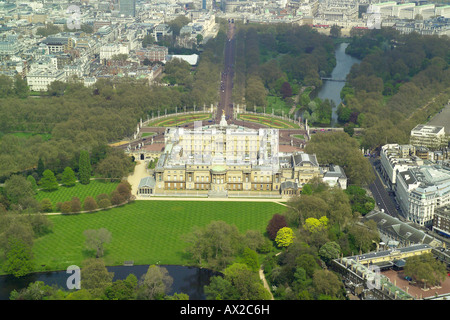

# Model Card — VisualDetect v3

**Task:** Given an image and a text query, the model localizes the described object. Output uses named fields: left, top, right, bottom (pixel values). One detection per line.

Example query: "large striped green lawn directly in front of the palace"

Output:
left=29, top=200, right=284, bottom=271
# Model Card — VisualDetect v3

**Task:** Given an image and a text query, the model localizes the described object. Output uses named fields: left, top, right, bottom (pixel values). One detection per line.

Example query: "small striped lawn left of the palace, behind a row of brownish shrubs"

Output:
left=36, top=180, right=118, bottom=207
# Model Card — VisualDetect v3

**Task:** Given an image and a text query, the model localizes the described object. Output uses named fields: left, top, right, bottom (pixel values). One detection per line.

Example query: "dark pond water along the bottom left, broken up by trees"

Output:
left=0, top=265, right=219, bottom=300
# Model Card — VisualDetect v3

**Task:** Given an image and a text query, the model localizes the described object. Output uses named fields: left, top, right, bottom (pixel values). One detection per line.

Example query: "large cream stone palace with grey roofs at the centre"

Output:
left=138, top=115, right=343, bottom=197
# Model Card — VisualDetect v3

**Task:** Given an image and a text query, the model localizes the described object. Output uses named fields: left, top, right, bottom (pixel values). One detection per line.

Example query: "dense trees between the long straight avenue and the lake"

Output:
left=233, top=24, right=336, bottom=123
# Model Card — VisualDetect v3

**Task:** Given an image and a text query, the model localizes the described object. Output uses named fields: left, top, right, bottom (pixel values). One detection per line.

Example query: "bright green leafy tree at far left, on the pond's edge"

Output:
left=4, top=237, right=34, bottom=278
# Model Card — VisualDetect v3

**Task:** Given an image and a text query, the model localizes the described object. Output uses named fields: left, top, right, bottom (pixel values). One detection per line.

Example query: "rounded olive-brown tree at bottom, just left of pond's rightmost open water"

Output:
left=138, top=265, right=173, bottom=300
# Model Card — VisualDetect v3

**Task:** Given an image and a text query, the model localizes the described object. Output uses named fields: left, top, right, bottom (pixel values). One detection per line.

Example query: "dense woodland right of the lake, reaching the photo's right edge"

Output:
left=338, top=28, right=450, bottom=149
